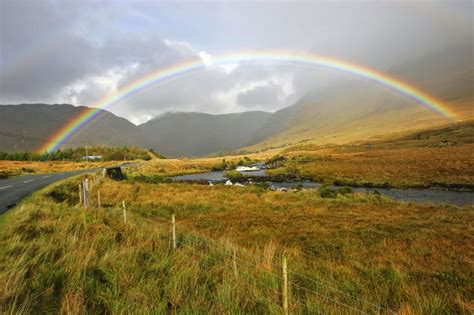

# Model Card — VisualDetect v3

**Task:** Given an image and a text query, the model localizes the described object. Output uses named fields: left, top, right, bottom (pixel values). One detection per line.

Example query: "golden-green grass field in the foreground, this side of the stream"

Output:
left=0, top=179, right=474, bottom=314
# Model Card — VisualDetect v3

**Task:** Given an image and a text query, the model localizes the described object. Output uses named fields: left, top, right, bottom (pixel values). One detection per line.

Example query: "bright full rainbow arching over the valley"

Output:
left=38, top=51, right=456, bottom=152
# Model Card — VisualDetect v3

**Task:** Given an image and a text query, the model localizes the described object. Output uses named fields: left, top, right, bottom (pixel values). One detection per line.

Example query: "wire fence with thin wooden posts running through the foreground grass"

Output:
left=79, top=178, right=396, bottom=314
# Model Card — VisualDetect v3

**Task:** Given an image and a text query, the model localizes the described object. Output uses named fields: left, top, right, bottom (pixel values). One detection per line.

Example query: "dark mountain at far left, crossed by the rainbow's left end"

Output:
left=0, top=104, right=145, bottom=151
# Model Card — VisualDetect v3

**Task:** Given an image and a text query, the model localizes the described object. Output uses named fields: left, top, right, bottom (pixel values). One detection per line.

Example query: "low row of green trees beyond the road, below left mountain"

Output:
left=0, top=146, right=162, bottom=161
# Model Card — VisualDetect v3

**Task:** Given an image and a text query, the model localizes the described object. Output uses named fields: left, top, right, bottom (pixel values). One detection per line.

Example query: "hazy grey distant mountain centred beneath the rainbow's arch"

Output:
left=139, top=111, right=272, bottom=156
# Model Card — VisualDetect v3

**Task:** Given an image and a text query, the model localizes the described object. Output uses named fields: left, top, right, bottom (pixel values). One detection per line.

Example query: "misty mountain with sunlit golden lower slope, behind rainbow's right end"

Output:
left=244, top=47, right=474, bottom=150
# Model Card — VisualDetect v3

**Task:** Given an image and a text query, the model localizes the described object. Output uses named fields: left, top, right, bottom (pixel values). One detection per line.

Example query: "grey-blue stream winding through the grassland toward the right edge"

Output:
left=172, top=170, right=474, bottom=206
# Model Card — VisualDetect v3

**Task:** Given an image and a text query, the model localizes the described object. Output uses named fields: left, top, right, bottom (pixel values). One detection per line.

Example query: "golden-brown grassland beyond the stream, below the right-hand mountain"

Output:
left=264, top=122, right=474, bottom=190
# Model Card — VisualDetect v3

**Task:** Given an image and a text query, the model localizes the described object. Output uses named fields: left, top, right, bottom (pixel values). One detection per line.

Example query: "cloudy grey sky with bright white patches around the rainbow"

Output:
left=0, top=0, right=473, bottom=124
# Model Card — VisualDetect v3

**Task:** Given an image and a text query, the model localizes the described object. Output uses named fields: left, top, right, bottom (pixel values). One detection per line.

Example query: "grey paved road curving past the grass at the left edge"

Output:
left=0, top=168, right=98, bottom=215
